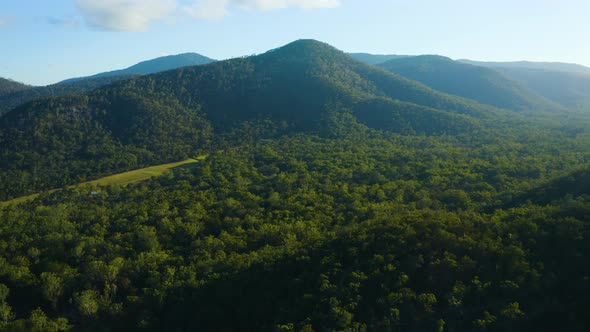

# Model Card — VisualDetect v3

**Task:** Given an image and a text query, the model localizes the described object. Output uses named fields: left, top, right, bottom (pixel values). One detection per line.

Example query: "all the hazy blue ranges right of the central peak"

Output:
left=351, top=53, right=590, bottom=110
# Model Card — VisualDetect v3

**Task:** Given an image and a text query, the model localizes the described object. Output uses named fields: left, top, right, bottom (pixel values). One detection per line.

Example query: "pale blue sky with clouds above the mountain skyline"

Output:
left=0, top=0, right=590, bottom=85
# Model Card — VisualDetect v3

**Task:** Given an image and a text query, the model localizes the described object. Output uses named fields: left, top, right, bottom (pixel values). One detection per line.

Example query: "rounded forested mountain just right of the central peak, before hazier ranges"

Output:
left=379, top=55, right=560, bottom=110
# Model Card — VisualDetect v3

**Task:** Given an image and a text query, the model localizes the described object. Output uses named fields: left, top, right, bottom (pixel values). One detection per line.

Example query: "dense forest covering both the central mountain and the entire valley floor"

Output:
left=0, top=41, right=590, bottom=332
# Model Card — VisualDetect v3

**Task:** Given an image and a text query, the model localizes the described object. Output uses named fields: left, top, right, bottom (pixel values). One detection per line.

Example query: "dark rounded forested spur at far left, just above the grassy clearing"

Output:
left=0, top=93, right=211, bottom=200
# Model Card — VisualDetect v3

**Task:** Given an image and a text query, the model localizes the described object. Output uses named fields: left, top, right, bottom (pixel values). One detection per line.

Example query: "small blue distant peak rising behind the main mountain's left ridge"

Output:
left=60, top=53, right=216, bottom=83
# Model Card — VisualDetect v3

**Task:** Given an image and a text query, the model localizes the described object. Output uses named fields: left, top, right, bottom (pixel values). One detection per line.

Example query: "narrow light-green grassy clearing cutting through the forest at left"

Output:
left=0, top=156, right=206, bottom=207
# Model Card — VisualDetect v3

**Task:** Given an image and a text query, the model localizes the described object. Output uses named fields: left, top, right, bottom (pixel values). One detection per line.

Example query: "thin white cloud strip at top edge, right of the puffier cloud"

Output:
left=185, top=0, right=340, bottom=20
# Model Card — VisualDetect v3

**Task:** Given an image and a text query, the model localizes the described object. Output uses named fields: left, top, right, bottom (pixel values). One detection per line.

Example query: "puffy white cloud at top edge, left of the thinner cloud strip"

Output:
left=75, top=0, right=177, bottom=31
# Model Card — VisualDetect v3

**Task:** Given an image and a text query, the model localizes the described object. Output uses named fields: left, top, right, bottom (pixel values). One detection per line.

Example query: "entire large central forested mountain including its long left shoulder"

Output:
left=0, top=40, right=502, bottom=199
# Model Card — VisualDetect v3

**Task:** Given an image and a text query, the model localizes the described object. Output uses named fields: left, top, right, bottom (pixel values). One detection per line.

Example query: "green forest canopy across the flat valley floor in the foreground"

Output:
left=0, top=131, right=590, bottom=331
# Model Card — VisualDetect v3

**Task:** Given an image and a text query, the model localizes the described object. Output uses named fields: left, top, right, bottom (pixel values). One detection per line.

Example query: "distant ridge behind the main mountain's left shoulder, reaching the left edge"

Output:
left=0, top=53, right=215, bottom=116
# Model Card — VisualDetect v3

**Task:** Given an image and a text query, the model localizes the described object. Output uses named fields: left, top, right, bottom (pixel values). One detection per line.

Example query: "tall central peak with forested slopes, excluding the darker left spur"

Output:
left=117, top=40, right=495, bottom=122
